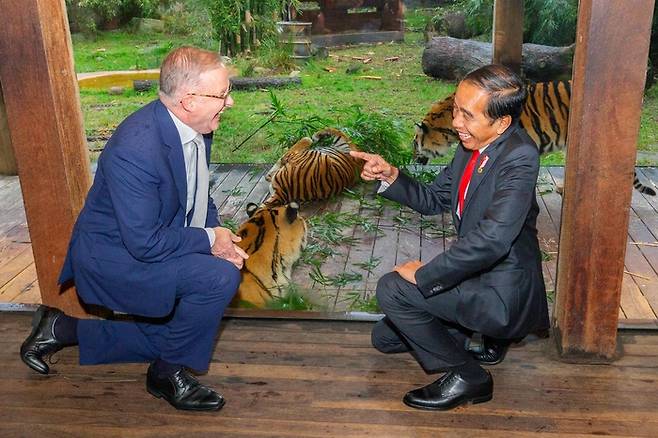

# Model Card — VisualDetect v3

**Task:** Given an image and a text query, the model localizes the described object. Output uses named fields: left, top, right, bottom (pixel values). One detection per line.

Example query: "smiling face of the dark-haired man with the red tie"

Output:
left=452, top=82, right=512, bottom=150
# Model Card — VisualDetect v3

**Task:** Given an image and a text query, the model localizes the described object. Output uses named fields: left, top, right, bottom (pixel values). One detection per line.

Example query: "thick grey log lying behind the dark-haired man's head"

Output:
left=422, top=37, right=574, bottom=82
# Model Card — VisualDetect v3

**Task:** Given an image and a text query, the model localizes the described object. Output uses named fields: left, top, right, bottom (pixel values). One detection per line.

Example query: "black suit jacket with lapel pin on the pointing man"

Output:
left=382, top=124, right=549, bottom=338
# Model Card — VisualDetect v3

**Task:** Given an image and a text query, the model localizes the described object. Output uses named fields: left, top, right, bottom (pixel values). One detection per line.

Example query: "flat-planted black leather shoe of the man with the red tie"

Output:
left=402, top=371, right=493, bottom=411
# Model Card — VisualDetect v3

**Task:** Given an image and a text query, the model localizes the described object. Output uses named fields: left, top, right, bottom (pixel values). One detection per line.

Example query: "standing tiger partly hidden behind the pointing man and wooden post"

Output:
left=412, top=81, right=656, bottom=196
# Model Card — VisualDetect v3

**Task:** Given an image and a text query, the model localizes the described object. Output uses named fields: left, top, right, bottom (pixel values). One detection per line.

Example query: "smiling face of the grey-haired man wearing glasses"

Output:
left=180, top=68, right=233, bottom=134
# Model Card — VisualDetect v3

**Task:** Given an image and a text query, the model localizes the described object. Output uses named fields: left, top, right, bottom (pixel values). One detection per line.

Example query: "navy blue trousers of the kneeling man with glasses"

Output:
left=78, top=254, right=240, bottom=371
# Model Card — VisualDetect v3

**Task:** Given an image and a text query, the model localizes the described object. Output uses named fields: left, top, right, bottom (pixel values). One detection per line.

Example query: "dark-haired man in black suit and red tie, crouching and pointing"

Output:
left=352, top=65, right=549, bottom=410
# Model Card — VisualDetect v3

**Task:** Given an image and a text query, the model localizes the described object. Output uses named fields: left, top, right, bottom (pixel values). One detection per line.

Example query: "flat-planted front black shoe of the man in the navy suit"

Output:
left=146, top=365, right=225, bottom=411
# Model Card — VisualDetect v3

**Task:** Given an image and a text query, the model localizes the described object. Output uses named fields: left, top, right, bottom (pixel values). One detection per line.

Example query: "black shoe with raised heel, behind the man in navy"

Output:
left=21, top=305, right=66, bottom=374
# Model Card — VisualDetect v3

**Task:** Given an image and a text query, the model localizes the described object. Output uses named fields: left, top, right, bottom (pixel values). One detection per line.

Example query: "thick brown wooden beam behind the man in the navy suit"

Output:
left=0, top=0, right=90, bottom=316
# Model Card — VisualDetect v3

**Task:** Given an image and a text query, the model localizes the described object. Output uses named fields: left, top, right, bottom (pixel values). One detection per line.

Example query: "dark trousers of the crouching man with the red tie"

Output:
left=372, top=272, right=474, bottom=372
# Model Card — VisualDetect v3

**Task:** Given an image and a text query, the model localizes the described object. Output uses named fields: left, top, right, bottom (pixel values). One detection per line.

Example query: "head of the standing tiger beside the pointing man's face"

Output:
left=412, top=94, right=459, bottom=164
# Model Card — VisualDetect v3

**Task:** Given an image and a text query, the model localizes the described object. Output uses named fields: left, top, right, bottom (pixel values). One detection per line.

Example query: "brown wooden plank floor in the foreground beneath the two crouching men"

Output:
left=0, top=312, right=658, bottom=438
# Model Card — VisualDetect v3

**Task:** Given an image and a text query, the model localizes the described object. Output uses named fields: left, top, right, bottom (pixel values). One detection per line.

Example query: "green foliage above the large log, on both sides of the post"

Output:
left=463, top=0, right=578, bottom=46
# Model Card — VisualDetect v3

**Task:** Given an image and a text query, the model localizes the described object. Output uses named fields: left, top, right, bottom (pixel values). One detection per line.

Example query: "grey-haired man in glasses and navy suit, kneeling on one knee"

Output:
left=21, top=47, right=247, bottom=411
